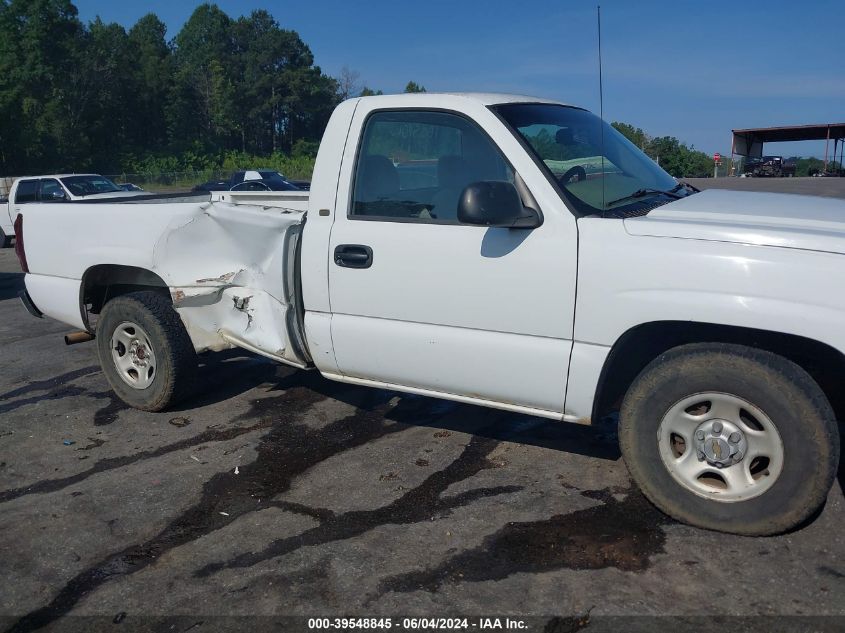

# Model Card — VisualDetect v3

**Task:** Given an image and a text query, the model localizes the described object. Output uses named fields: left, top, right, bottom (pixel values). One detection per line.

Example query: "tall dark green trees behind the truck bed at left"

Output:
left=0, top=0, right=338, bottom=177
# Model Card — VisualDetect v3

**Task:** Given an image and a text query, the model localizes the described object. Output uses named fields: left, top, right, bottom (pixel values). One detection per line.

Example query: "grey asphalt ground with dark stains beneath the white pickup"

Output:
left=0, top=179, right=845, bottom=631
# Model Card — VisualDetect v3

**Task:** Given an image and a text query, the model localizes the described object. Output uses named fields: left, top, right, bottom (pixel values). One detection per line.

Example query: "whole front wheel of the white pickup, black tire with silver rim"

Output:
left=619, top=343, right=839, bottom=536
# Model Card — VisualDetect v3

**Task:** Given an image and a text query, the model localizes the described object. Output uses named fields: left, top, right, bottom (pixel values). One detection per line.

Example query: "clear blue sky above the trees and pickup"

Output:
left=75, top=0, right=845, bottom=156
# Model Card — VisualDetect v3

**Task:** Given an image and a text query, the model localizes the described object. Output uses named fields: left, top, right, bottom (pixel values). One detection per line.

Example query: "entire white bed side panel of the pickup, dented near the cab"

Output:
left=25, top=192, right=308, bottom=365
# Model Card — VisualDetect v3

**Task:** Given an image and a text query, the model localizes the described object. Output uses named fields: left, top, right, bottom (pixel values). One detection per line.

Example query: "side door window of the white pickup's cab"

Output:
left=349, top=111, right=513, bottom=224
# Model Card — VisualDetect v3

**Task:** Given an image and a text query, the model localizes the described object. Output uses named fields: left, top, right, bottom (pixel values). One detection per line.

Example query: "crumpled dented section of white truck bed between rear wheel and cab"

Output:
left=153, top=202, right=304, bottom=366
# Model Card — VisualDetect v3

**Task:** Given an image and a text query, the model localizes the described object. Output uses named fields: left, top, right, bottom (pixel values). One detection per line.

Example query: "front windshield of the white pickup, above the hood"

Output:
left=495, top=104, right=690, bottom=214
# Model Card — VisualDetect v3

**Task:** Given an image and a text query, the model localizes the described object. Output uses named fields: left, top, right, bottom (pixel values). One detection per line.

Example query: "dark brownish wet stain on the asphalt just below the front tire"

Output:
left=379, top=489, right=670, bottom=593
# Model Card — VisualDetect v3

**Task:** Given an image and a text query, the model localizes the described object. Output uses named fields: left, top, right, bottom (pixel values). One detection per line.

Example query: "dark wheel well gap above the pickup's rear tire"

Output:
left=79, top=264, right=170, bottom=332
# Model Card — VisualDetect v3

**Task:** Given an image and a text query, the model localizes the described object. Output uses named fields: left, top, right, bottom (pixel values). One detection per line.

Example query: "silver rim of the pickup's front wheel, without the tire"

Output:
left=657, top=392, right=784, bottom=502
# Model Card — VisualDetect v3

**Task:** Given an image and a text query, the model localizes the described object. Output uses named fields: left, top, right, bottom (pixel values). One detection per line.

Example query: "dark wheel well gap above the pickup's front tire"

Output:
left=593, top=321, right=845, bottom=420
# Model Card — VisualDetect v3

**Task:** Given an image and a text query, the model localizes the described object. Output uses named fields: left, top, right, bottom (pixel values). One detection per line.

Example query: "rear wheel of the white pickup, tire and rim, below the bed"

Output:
left=96, top=291, right=197, bottom=411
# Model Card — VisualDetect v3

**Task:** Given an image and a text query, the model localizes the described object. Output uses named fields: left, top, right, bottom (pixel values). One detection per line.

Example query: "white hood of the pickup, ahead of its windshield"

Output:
left=624, top=189, right=845, bottom=254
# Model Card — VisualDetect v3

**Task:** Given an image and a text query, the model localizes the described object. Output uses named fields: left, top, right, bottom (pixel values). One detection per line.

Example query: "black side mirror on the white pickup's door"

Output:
left=458, top=180, right=541, bottom=229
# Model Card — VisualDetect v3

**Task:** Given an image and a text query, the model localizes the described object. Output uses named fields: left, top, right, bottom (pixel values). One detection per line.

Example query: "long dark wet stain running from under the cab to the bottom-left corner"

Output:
left=10, top=375, right=448, bottom=631
